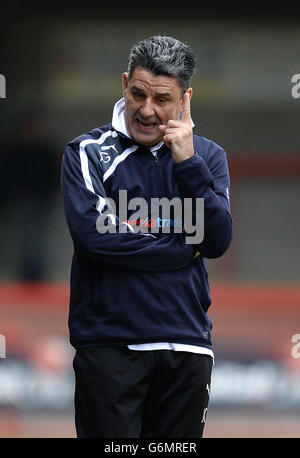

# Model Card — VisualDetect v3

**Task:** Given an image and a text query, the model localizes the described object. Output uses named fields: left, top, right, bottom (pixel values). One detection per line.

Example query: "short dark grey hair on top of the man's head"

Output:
left=128, top=35, right=195, bottom=94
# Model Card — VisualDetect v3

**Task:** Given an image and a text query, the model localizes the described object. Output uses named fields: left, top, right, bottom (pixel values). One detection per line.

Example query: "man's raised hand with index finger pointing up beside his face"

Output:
left=159, top=92, right=194, bottom=162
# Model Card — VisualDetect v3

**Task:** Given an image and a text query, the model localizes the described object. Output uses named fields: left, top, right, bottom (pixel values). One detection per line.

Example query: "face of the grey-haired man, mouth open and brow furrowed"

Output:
left=123, top=67, right=188, bottom=147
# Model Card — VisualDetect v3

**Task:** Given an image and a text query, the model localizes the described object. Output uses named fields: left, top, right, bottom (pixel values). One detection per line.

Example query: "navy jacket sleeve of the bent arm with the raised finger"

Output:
left=173, top=148, right=233, bottom=258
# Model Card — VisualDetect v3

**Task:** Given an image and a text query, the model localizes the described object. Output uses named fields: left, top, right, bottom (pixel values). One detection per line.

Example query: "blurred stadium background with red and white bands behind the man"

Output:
left=0, top=1, right=300, bottom=437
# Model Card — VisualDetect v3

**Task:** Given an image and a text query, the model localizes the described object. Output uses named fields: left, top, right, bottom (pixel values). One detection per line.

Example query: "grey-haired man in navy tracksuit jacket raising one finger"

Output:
left=62, top=36, right=232, bottom=438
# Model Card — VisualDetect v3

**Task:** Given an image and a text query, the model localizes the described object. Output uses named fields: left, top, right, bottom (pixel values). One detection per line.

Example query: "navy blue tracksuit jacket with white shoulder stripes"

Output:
left=62, top=124, right=232, bottom=348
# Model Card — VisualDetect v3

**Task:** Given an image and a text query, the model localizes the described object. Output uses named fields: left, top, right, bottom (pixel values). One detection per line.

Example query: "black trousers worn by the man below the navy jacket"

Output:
left=73, top=346, right=212, bottom=438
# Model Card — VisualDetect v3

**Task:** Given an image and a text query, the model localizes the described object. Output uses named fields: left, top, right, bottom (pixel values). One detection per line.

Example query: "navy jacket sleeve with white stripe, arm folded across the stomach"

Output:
left=61, top=144, right=195, bottom=272
